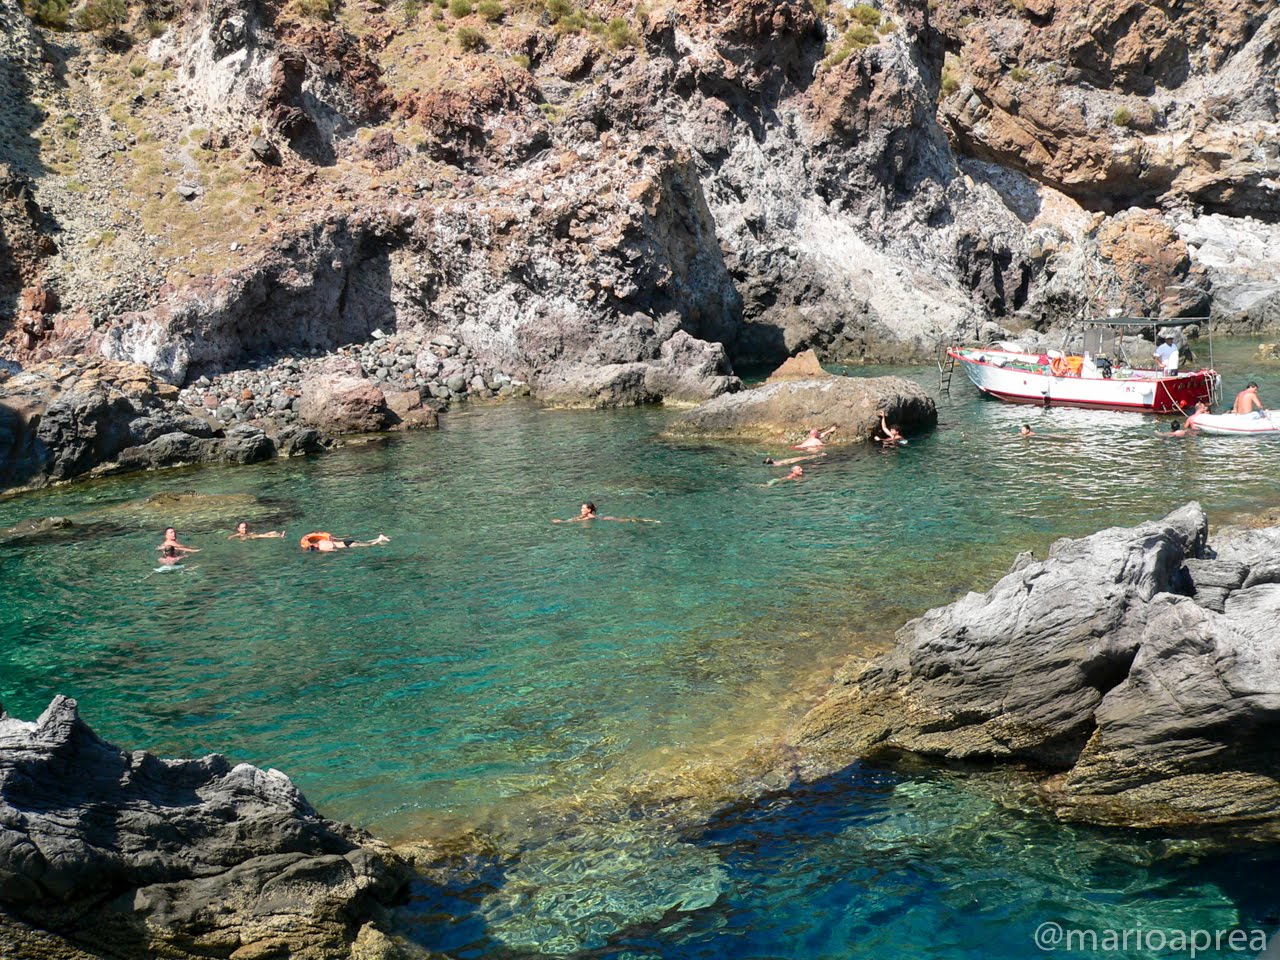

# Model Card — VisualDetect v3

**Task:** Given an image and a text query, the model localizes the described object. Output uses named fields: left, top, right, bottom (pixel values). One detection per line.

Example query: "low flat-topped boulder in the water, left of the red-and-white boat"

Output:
left=666, top=375, right=938, bottom=443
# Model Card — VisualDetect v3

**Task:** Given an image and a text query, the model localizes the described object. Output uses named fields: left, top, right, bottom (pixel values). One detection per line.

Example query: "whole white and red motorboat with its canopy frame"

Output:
left=946, top=317, right=1221, bottom=413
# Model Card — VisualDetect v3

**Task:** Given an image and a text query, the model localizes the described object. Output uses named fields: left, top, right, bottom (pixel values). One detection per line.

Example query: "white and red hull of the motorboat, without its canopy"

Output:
left=947, top=348, right=1219, bottom=413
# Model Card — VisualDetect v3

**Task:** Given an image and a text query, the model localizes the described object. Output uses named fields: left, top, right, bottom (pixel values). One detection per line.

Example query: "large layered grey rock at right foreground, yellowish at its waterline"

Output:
left=797, top=503, right=1280, bottom=838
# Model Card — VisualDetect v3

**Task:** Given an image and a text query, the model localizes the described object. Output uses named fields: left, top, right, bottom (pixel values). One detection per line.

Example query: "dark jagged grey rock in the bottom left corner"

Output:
left=0, top=696, right=410, bottom=960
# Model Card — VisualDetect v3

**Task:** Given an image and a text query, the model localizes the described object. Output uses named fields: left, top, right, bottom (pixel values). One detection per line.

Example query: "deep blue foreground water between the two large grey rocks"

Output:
left=401, top=762, right=1280, bottom=960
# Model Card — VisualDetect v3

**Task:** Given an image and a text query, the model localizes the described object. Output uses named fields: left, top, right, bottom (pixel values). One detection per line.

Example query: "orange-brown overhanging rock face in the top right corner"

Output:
left=940, top=0, right=1280, bottom=218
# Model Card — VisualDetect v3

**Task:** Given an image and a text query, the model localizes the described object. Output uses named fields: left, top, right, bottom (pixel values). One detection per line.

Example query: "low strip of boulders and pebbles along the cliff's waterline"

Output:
left=0, top=343, right=937, bottom=493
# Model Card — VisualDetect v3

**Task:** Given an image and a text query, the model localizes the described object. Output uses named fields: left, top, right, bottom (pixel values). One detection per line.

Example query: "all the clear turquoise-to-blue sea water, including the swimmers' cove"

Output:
left=0, top=342, right=1280, bottom=956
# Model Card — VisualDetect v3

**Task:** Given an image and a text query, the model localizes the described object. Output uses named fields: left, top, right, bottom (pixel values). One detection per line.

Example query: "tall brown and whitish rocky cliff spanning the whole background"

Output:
left=0, top=0, right=1280, bottom=389
